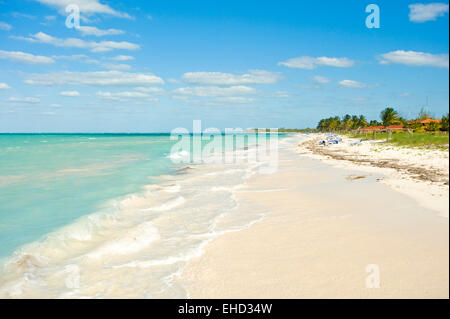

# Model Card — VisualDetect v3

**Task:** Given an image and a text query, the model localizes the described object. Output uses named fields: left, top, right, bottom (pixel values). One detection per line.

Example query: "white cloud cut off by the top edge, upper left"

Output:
left=35, top=0, right=131, bottom=18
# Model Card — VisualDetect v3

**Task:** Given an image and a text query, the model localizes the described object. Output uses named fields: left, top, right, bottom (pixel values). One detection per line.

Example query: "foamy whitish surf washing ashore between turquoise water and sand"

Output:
left=0, top=138, right=270, bottom=298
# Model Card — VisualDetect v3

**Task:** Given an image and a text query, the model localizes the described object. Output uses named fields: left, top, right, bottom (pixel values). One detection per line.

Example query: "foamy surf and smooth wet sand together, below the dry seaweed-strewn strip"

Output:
left=0, top=134, right=448, bottom=298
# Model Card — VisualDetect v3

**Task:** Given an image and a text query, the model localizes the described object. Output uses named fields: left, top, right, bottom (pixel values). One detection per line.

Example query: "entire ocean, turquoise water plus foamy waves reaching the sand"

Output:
left=0, top=134, right=284, bottom=298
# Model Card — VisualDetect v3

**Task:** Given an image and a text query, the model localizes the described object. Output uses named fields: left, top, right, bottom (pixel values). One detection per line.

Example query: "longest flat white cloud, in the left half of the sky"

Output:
left=25, top=71, right=164, bottom=86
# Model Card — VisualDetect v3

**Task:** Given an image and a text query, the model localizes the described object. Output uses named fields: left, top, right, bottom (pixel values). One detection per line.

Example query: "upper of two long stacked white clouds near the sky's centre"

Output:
left=183, top=70, right=281, bottom=85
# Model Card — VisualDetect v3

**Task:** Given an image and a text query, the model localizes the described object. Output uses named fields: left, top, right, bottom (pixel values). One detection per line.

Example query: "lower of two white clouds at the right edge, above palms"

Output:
left=380, top=50, right=449, bottom=69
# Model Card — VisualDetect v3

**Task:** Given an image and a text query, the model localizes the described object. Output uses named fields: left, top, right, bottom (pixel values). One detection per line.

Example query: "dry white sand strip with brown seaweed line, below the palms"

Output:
left=296, top=134, right=449, bottom=218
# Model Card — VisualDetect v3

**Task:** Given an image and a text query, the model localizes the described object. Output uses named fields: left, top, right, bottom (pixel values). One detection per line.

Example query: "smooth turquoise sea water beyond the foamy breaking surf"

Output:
left=0, top=134, right=179, bottom=258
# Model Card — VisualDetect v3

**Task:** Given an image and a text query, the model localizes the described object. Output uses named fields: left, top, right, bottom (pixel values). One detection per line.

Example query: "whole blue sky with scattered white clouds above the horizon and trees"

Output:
left=0, top=0, right=449, bottom=132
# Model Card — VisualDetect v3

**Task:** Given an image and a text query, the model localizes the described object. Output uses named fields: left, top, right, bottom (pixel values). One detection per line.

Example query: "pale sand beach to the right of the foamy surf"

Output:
left=179, top=136, right=449, bottom=298
